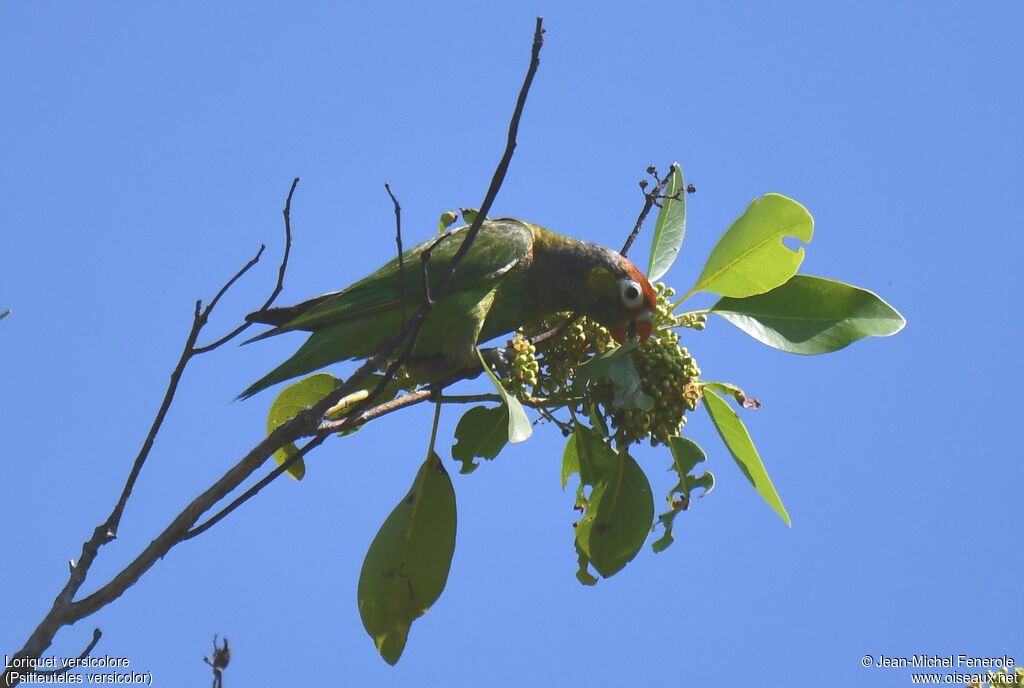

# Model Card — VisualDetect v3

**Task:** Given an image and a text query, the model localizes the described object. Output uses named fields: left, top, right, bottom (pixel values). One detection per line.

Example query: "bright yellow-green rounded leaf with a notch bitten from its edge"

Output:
left=681, top=194, right=814, bottom=300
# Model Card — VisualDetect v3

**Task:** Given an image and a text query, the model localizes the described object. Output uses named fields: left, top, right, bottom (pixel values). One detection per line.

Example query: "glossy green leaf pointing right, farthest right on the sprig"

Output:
left=712, top=274, right=906, bottom=355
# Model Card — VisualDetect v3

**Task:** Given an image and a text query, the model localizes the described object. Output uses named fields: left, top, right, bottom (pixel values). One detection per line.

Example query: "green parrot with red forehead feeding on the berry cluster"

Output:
left=240, top=218, right=656, bottom=398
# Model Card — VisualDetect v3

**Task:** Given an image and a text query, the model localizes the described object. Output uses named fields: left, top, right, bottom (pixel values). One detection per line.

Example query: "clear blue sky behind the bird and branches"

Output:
left=0, top=2, right=1024, bottom=686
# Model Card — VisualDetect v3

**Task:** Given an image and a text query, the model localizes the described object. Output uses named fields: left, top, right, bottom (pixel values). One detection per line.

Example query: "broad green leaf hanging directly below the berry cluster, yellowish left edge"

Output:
left=577, top=441, right=654, bottom=578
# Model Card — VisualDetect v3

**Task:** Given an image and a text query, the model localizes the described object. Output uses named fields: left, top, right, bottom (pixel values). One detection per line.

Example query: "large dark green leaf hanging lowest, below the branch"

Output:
left=357, top=452, right=456, bottom=664
